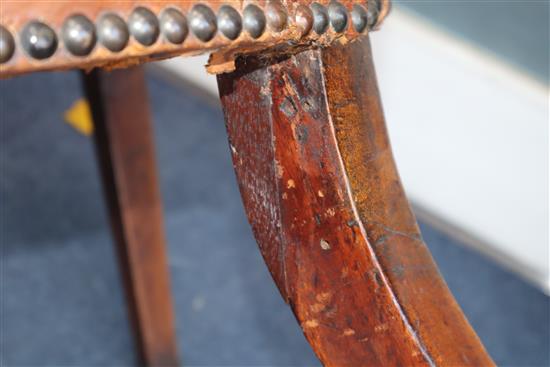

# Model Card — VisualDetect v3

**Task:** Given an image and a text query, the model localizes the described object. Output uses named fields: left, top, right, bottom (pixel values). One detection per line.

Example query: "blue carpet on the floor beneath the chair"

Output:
left=0, top=73, right=550, bottom=366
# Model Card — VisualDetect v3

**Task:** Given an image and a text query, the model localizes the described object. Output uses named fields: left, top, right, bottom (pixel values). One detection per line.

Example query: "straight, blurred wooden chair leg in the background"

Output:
left=83, top=68, right=178, bottom=366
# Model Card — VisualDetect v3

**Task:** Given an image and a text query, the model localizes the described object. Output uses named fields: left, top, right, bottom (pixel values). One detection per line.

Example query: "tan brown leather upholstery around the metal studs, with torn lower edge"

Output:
left=0, top=0, right=389, bottom=77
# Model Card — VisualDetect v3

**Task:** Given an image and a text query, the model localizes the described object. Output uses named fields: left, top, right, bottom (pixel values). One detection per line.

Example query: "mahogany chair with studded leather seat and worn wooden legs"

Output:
left=0, top=0, right=493, bottom=366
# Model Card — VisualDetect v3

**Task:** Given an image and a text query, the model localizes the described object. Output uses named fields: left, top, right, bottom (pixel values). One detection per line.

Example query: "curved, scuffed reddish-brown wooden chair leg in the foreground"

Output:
left=218, top=38, right=493, bottom=366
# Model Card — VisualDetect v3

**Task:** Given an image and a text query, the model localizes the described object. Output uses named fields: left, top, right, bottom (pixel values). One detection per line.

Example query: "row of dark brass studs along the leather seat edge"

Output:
left=0, top=0, right=379, bottom=63
